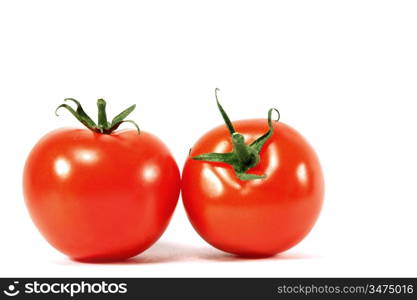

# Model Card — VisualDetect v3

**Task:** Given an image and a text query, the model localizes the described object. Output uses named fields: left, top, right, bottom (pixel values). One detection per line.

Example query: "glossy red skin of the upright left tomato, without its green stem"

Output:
left=23, top=129, right=180, bottom=261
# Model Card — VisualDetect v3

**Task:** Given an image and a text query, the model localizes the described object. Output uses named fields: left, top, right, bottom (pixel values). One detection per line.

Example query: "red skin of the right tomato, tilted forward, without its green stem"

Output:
left=182, top=119, right=324, bottom=256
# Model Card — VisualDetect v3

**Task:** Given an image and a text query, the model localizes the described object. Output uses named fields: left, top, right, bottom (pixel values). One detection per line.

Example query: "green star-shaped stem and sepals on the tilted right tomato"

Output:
left=192, top=88, right=280, bottom=180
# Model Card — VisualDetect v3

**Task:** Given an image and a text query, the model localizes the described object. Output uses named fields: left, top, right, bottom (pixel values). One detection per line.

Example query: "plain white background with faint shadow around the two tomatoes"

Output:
left=0, top=0, right=417, bottom=277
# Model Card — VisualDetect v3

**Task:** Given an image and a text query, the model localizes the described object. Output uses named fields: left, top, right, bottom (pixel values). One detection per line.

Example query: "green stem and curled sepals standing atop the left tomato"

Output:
left=55, top=98, right=140, bottom=134
